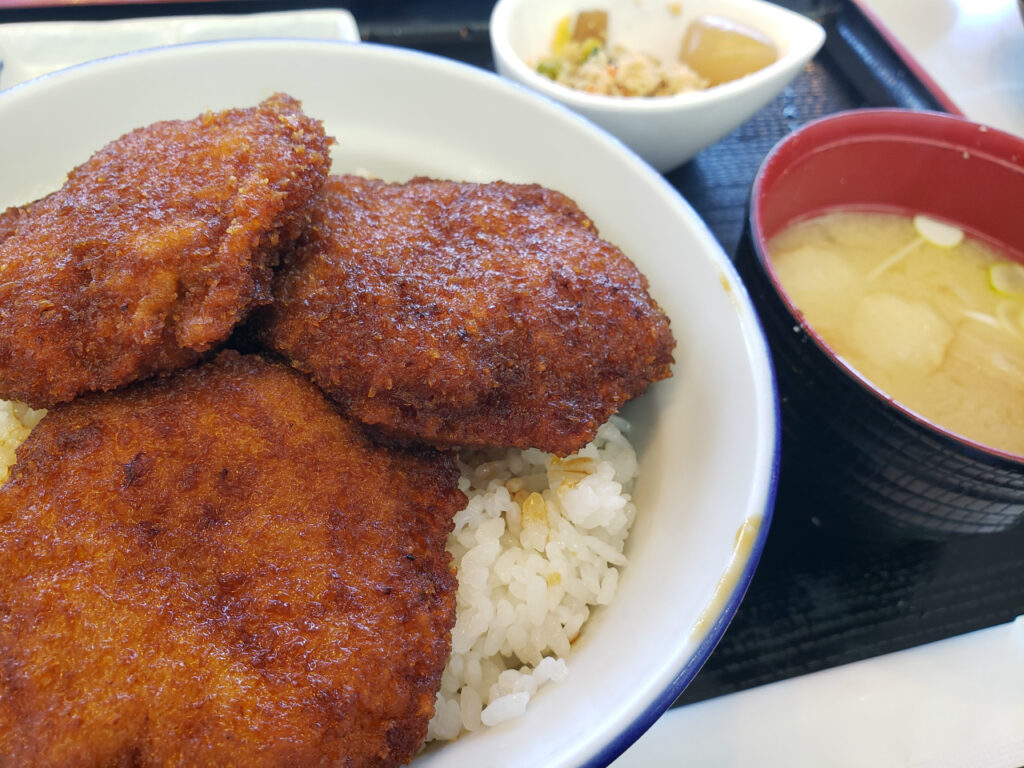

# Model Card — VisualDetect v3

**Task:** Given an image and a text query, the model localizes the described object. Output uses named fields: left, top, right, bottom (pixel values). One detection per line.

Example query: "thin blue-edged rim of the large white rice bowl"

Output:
left=0, top=38, right=782, bottom=768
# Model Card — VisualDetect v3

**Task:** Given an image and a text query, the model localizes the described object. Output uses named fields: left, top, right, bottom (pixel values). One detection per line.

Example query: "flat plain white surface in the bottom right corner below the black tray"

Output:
left=611, top=616, right=1024, bottom=768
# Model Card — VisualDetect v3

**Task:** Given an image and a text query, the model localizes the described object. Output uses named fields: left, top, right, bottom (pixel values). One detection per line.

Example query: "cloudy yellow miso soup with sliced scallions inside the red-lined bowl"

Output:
left=768, top=211, right=1024, bottom=455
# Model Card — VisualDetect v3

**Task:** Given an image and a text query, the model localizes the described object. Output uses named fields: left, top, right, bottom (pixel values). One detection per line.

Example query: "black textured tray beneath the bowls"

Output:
left=0, top=0, right=1024, bottom=705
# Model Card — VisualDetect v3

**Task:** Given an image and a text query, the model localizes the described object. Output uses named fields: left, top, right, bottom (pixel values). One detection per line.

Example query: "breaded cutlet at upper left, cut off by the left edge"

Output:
left=0, top=95, right=330, bottom=407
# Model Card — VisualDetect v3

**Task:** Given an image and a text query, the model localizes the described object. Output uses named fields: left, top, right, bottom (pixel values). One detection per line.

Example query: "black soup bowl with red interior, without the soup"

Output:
left=736, top=110, right=1024, bottom=539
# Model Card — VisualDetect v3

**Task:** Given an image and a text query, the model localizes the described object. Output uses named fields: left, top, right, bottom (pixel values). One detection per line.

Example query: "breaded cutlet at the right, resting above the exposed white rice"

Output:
left=256, top=176, right=675, bottom=456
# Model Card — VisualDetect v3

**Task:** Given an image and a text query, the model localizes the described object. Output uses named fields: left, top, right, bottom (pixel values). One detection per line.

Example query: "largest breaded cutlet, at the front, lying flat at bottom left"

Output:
left=0, top=352, right=465, bottom=768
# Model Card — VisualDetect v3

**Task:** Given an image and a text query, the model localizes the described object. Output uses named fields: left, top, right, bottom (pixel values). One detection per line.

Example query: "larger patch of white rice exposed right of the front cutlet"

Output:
left=427, top=417, right=637, bottom=740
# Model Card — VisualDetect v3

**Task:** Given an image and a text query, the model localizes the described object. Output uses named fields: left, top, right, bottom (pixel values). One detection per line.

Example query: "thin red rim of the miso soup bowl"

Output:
left=746, top=105, right=1024, bottom=470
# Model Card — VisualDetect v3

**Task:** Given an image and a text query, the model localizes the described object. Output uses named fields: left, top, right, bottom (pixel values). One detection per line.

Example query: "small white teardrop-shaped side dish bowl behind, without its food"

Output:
left=490, top=0, right=825, bottom=171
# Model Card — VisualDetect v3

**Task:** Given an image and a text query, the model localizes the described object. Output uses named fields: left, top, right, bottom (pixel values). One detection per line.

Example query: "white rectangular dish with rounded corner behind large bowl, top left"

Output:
left=0, top=9, right=359, bottom=90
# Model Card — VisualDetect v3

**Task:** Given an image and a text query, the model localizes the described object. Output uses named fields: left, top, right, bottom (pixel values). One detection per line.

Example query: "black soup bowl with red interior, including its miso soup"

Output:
left=737, top=110, right=1024, bottom=540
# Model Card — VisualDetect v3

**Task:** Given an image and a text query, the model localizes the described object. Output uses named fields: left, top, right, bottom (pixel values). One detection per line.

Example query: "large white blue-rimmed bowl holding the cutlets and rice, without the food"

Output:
left=0, top=40, right=777, bottom=768
